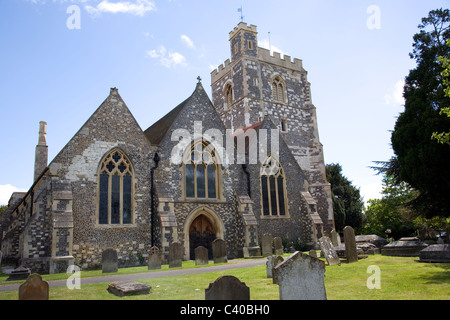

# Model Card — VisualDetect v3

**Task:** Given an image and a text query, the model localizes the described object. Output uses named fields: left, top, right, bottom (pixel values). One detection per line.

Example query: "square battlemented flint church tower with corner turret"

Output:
left=211, top=22, right=334, bottom=233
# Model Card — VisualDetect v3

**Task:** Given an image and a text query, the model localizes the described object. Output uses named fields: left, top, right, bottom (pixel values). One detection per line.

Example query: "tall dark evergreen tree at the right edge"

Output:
left=381, top=9, right=450, bottom=217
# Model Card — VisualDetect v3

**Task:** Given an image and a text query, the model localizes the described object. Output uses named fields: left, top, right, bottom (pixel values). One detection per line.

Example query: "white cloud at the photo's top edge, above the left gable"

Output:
left=84, top=0, right=156, bottom=16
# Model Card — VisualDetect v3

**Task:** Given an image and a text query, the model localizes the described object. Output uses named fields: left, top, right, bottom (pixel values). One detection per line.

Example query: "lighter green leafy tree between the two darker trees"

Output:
left=362, top=175, right=419, bottom=239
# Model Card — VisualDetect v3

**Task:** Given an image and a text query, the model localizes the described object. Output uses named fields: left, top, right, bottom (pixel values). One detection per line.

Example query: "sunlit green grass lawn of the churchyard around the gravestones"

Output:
left=0, top=255, right=450, bottom=300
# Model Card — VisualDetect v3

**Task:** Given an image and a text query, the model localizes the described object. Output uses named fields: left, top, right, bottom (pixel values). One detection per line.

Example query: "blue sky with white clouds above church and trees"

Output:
left=0, top=0, right=449, bottom=204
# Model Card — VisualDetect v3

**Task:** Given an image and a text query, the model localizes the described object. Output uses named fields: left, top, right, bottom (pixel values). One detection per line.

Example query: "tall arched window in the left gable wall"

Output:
left=98, top=149, right=134, bottom=224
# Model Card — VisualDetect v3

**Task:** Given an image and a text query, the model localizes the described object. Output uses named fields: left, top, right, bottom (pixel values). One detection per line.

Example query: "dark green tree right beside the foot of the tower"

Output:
left=326, top=163, right=364, bottom=231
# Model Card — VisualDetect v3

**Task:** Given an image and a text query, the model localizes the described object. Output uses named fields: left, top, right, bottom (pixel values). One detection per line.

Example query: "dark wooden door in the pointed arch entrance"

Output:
left=189, top=214, right=216, bottom=260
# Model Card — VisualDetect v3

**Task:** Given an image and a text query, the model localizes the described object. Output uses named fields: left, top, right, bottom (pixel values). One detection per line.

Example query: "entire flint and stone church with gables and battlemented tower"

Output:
left=0, top=22, right=334, bottom=273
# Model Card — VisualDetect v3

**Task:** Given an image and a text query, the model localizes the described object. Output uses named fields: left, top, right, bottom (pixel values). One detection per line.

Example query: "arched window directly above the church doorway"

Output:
left=184, top=140, right=219, bottom=199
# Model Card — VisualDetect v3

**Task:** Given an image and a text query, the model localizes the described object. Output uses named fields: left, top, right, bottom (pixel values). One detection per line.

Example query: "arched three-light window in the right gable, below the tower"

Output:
left=260, top=156, right=287, bottom=217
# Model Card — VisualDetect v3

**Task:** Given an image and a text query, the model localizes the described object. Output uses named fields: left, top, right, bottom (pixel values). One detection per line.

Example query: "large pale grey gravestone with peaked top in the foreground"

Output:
left=273, top=252, right=331, bottom=300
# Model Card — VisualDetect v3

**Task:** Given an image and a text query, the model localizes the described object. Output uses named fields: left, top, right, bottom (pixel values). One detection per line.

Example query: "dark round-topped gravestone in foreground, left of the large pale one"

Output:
left=205, top=276, right=250, bottom=300
